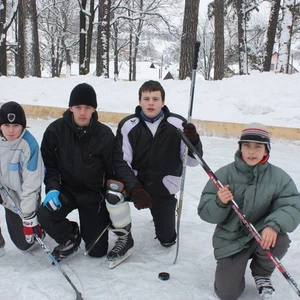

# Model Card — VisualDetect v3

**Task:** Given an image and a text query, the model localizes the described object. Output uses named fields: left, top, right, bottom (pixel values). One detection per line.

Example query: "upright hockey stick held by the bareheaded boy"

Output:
left=173, top=41, right=200, bottom=264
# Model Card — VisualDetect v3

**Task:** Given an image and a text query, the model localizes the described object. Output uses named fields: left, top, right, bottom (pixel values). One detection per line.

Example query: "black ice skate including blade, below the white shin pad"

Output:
left=107, top=224, right=134, bottom=269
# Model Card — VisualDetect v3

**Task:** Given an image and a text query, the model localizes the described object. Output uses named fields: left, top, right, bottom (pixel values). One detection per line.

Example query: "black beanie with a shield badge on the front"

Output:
left=0, top=101, right=26, bottom=128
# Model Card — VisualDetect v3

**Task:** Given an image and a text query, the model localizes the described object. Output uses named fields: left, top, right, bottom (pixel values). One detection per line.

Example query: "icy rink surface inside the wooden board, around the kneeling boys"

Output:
left=0, top=120, right=300, bottom=300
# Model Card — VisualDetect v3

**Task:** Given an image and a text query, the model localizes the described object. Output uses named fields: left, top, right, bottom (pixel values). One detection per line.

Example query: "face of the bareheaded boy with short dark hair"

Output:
left=139, top=91, right=165, bottom=119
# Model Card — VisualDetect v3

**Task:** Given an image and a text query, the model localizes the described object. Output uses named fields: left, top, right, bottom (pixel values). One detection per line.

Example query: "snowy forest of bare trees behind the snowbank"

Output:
left=0, top=0, right=300, bottom=81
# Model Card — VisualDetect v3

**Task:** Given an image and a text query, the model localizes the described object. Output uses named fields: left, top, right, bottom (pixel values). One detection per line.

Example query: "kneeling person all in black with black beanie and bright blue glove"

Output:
left=38, top=83, right=114, bottom=260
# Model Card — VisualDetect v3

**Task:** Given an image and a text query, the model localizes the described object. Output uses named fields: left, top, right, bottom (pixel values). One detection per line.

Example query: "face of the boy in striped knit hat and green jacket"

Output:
left=241, top=142, right=268, bottom=166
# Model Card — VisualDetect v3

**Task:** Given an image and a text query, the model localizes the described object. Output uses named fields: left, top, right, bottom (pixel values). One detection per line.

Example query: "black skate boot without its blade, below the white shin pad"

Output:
left=107, top=224, right=134, bottom=261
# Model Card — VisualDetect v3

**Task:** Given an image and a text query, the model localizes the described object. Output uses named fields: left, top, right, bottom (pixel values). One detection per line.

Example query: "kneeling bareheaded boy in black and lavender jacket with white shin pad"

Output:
left=106, top=80, right=202, bottom=265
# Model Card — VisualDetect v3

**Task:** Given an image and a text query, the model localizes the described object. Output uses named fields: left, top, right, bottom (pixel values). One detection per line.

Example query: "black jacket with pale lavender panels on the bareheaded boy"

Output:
left=113, top=106, right=202, bottom=197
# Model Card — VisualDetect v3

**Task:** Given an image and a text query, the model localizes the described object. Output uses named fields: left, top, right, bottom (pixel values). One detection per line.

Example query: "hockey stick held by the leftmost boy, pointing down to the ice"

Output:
left=0, top=184, right=83, bottom=300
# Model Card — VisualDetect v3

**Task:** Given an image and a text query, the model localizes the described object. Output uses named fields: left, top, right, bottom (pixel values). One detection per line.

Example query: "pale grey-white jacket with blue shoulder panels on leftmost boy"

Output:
left=0, top=129, right=44, bottom=217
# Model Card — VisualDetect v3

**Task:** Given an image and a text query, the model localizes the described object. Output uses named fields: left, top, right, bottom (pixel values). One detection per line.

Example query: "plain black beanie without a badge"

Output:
left=69, top=83, right=97, bottom=108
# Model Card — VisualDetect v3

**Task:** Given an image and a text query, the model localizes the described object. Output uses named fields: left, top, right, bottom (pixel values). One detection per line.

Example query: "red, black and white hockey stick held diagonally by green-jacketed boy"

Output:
left=177, top=129, right=300, bottom=297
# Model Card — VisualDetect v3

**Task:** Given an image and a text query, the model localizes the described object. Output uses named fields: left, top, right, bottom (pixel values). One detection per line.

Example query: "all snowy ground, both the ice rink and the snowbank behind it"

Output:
left=0, top=69, right=300, bottom=300
